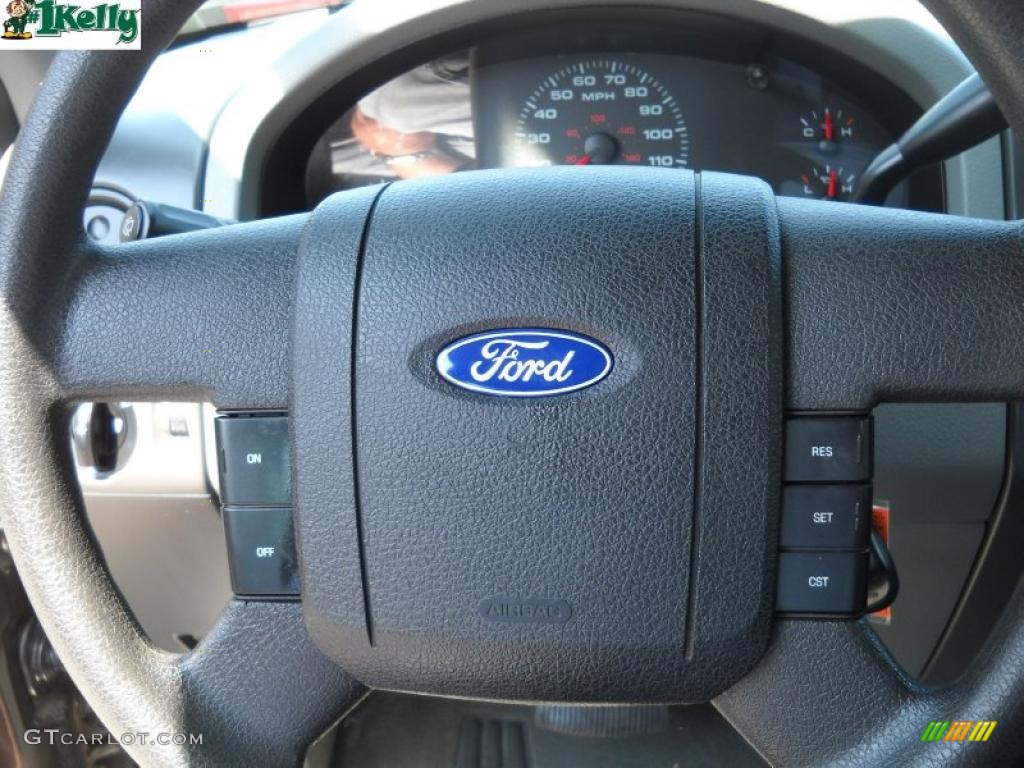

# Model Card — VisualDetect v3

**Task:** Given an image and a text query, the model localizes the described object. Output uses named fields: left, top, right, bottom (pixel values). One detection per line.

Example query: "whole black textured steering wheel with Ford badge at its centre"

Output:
left=0, top=0, right=1024, bottom=766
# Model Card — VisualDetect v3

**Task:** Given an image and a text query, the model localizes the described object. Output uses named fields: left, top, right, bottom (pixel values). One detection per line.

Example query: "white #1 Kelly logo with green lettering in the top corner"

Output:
left=0, top=0, right=142, bottom=52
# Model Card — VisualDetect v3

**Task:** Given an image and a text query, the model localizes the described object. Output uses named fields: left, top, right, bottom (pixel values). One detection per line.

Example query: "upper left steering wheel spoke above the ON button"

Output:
left=54, top=216, right=305, bottom=409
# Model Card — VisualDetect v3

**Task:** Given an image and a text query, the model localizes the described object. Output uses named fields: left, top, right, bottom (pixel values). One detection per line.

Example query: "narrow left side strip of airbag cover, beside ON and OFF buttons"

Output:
left=289, top=188, right=380, bottom=658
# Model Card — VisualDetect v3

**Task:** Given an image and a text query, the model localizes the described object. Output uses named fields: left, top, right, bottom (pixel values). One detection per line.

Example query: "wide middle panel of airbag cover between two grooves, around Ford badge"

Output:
left=360, top=169, right=696, bottom=700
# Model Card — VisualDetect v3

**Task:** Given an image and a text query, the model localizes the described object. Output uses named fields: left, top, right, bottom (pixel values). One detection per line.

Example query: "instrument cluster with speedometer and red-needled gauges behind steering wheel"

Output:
left=304, top=18, right=942, bottom=210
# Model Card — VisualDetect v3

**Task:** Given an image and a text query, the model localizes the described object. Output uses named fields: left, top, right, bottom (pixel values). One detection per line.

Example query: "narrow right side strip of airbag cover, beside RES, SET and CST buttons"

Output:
left=687, top=173, right=782, bottom=665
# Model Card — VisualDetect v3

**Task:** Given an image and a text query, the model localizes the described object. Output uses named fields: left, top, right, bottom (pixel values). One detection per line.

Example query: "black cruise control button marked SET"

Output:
left=780, top=484, right=871, bottom=550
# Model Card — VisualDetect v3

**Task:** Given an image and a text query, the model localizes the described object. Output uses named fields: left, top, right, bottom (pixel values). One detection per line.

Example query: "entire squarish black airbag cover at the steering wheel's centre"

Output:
left=294, top=169, right=781, bottom=700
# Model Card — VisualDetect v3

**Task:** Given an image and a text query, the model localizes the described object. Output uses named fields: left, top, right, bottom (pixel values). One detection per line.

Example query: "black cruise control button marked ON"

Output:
left=216, top=415, right=292, bottom=506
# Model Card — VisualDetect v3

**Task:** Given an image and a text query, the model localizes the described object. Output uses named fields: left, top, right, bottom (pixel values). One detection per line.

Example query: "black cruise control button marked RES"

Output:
left=785, top=417, right=871, bottom=482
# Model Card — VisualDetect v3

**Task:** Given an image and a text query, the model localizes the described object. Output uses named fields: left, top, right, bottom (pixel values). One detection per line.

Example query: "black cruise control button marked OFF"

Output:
left=224, top=507, right=299, bottom=597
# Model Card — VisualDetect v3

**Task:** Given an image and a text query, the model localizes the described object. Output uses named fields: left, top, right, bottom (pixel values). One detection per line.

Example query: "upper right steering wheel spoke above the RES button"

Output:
left=778, top=198, right=1024, bottom=410
